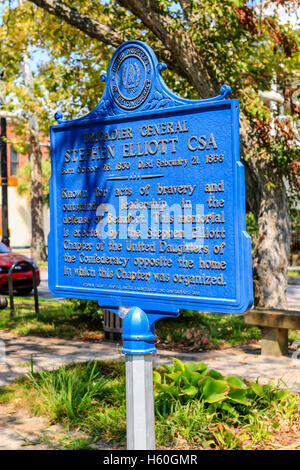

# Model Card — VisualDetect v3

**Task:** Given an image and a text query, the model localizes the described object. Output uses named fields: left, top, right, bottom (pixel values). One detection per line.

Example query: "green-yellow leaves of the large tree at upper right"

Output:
left=104, top=0, right=300, bottom=197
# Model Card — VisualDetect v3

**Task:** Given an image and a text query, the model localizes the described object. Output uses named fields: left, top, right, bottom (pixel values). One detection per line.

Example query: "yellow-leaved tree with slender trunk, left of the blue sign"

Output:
left=0, top=0, right=115, bottom=260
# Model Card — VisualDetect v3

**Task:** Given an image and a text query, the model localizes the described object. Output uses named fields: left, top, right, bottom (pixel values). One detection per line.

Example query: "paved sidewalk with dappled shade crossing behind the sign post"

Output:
left=0, top=332, right=300, bottom=392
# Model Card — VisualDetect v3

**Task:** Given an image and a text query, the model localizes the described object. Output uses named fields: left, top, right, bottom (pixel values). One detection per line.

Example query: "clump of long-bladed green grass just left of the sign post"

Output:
left=28, top=361, right=126, bottom=439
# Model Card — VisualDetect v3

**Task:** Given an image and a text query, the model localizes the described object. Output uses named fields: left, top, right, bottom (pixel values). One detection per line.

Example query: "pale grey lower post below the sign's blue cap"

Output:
left=125, top=354, right=155, bottom=450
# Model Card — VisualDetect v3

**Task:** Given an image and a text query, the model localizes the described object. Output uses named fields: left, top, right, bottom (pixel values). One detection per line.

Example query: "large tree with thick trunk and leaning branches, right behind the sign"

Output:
left=4, top=0, right=299, bottom=308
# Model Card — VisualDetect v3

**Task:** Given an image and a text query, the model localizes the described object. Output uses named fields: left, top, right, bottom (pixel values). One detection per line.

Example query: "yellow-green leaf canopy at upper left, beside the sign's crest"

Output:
left=0, top=1, right=107, bottom=134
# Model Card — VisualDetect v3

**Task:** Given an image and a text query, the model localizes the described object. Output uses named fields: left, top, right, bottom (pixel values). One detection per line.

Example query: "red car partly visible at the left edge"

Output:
left=0, top=242, right=40, bottom=294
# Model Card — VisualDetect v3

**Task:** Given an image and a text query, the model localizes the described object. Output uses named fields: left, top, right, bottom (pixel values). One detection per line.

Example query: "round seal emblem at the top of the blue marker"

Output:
left=110, top=46, right=152, bottom=109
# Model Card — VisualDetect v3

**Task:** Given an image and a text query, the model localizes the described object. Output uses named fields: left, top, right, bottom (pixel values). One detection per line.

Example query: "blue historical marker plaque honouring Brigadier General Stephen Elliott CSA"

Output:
left=49, top=41, right=252, bottom=315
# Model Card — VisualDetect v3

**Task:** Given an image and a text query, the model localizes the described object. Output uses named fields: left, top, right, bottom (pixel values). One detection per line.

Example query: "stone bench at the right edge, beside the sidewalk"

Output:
left=245, top=308, right=300, bottom=356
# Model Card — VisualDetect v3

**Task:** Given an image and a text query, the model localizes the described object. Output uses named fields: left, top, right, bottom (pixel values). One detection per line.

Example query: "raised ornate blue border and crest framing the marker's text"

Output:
left=48, top=41, right=253, bottom=315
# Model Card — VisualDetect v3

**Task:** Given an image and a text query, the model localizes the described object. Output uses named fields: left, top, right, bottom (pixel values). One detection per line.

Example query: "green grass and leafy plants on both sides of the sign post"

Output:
left=0, top=360, right=299, bottom=450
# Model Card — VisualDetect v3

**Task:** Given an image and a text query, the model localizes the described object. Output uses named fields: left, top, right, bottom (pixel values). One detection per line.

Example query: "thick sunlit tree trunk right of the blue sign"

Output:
left=241, top=119, right=291, bottom=309
